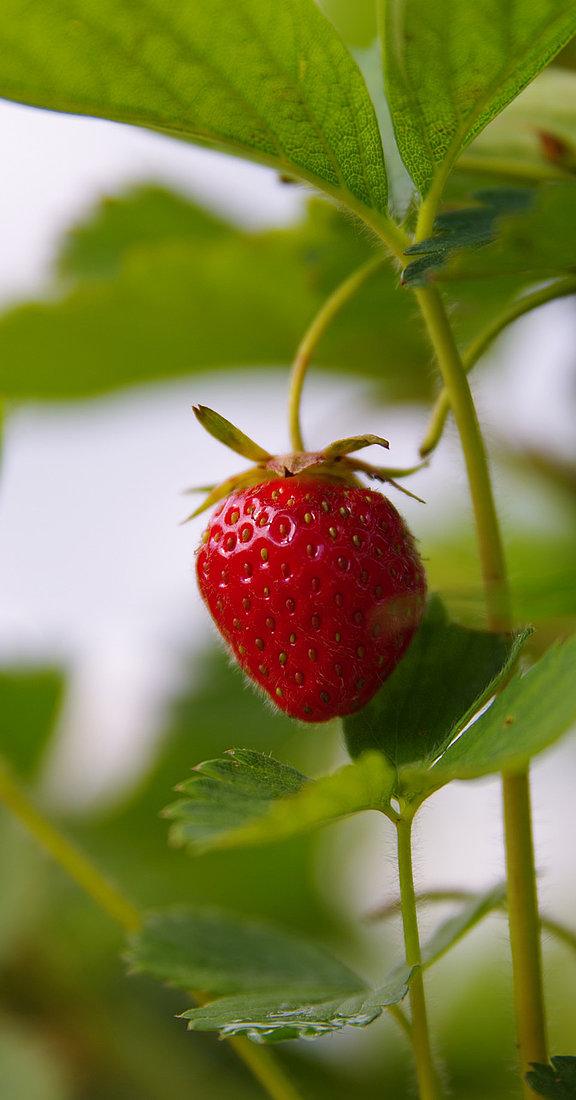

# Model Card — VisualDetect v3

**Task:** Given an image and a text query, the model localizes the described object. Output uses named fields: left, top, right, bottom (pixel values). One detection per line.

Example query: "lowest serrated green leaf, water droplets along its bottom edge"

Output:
left=128, top=908, right=410, bottom=1040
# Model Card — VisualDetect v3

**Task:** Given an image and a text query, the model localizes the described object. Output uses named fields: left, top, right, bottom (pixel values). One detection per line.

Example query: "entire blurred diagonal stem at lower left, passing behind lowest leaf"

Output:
left=0, top=758, right=301, bottom=1100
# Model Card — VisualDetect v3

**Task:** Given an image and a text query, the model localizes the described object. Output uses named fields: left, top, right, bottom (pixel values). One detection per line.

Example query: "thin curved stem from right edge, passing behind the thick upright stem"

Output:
left=420, top=277, right=576, bottom=458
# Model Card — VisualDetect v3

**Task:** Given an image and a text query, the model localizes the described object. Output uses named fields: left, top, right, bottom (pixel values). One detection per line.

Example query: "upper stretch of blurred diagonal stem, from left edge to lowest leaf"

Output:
left=0, top=759, right=141, bottom=932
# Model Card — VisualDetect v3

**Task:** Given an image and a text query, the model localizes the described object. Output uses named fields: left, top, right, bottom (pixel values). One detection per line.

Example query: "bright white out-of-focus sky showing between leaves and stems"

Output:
left=0, top=103, right=576, bottom=932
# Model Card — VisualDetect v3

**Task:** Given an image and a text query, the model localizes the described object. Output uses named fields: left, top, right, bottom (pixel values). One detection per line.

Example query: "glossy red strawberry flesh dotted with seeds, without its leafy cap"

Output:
left=197, top=476, right=425, bottom=722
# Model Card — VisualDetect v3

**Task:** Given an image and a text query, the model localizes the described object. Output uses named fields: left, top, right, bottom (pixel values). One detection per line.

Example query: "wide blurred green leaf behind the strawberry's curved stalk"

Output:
left=0, top=190, right=431, bottom=399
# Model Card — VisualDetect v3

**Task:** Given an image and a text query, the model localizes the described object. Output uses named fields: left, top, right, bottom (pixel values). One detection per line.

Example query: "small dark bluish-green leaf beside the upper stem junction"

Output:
left=402, top=187, right=535, bottom=286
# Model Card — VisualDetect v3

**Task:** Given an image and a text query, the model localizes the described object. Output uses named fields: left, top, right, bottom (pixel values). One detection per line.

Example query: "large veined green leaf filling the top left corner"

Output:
left=0, top=0, right=386, bottom=221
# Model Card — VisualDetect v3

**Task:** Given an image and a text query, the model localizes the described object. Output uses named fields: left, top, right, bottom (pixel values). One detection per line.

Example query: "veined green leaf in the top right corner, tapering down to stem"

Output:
left=380, top=0, right=576, bottom=195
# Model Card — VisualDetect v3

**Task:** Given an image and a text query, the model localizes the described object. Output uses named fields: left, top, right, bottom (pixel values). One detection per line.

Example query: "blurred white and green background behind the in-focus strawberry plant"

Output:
left=0, top=6, right=576, bottom=1100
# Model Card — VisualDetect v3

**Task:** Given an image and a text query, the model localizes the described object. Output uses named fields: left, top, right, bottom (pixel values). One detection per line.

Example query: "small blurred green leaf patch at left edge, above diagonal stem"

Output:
left=0, top=669, right=65, bottom=779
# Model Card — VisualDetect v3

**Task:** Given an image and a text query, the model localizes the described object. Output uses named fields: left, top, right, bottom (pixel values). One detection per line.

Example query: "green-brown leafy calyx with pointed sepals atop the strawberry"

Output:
left=184, top=405, right=427, bottom=523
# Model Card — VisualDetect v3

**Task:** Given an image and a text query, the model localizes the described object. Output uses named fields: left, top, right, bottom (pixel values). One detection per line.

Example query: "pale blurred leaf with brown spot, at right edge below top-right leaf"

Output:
left=456, top=67, right=576, bottom=179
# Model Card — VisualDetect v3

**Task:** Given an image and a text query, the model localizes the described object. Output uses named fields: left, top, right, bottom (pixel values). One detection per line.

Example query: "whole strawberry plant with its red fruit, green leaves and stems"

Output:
left=0, top=0, right=576, bottom=1100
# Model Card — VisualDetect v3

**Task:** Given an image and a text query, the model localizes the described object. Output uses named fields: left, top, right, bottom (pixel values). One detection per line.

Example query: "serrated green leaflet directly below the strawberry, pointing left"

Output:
left=165, top=749, right=394, bottom=851
